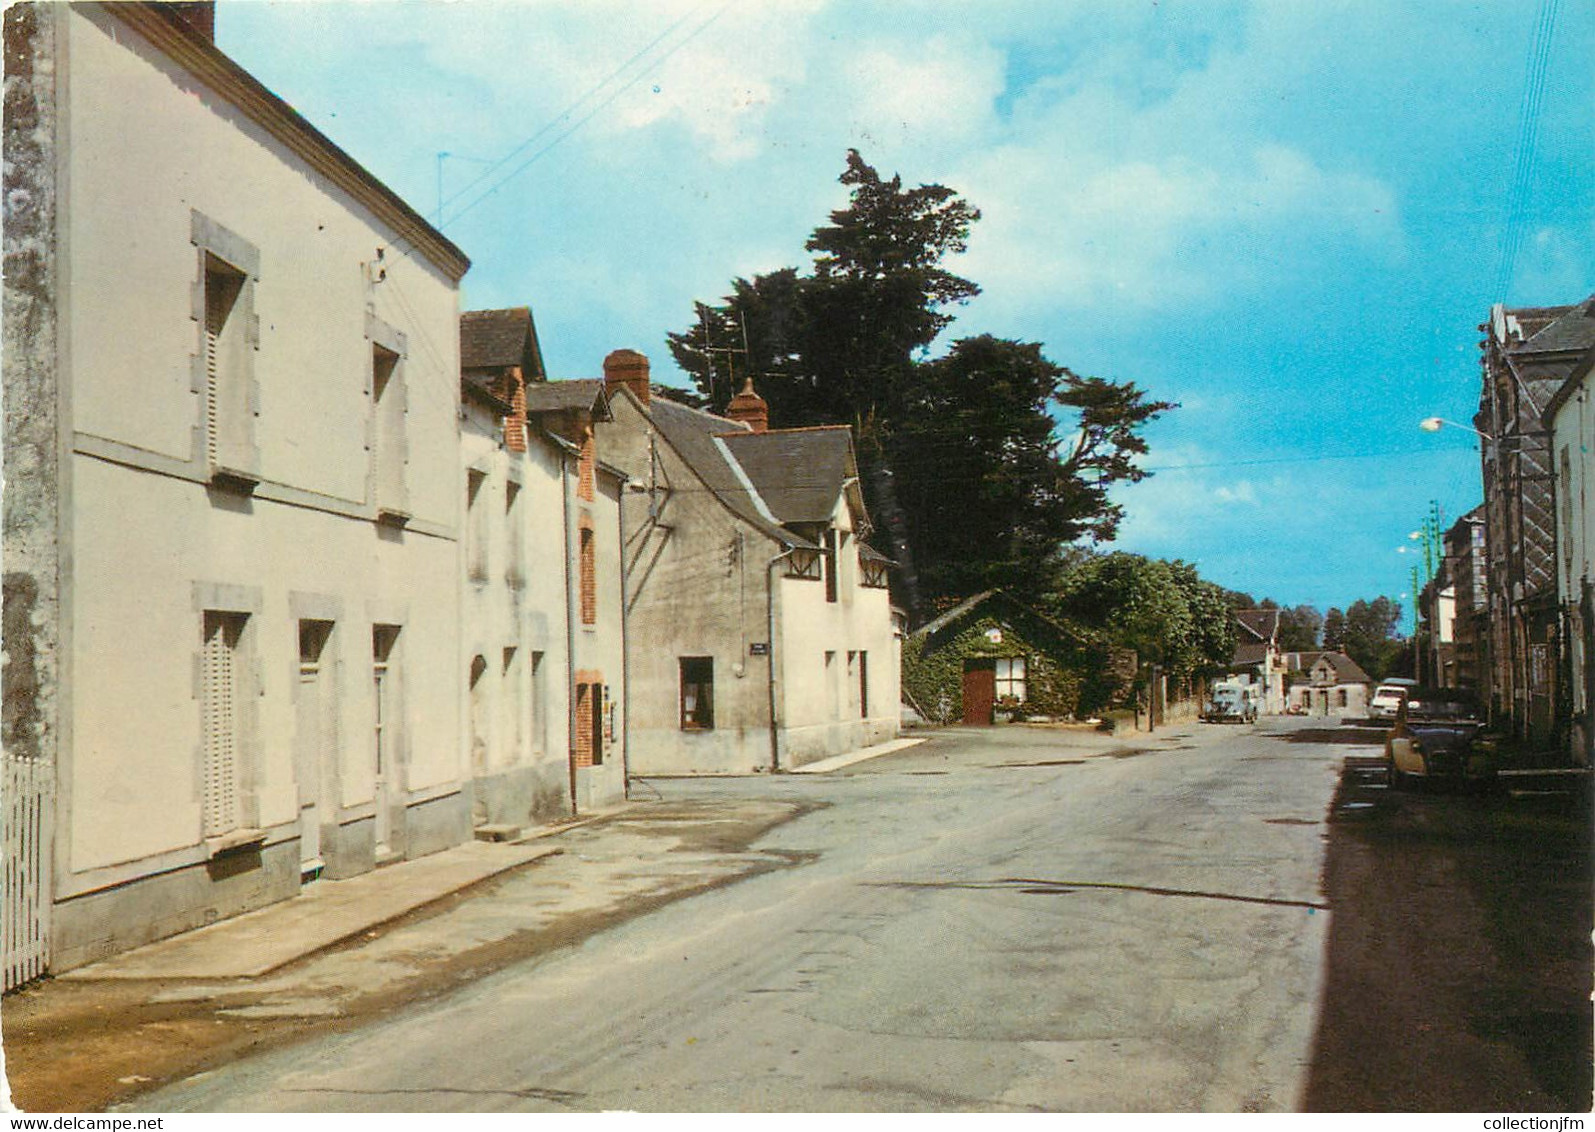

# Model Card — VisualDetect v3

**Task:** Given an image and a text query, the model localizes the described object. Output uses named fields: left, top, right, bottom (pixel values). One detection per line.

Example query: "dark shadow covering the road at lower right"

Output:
left=1297, top=758, right=1595, bottom=1111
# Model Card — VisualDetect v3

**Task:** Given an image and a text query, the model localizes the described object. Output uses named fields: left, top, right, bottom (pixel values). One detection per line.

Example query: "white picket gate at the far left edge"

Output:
left=0, top=754, right=56, bottom=990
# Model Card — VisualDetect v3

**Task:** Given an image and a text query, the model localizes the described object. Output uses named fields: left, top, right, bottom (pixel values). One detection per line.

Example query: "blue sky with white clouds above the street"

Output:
left=217, top=0, right=1595, bottom=621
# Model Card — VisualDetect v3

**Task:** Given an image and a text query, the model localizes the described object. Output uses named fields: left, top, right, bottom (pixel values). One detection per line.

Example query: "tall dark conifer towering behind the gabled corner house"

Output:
left=670, top=150, right=1172, bottom=612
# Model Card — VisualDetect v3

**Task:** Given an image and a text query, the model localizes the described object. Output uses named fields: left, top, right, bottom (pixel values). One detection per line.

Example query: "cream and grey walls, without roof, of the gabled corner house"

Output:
left=600, top=370, right=901, bottom=775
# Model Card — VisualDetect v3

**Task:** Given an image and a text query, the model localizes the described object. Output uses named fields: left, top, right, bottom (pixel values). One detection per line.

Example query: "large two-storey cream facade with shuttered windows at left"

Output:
left=6, top=5, right=471, bottom=969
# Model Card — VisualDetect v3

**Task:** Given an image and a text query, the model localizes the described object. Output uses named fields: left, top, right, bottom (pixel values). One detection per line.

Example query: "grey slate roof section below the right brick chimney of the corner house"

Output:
left=721, top=424, right=858, bottom=523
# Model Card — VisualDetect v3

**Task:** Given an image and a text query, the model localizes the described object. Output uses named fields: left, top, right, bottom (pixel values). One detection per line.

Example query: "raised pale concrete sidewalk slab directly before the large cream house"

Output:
left=61, top=826, right=568, bottom=981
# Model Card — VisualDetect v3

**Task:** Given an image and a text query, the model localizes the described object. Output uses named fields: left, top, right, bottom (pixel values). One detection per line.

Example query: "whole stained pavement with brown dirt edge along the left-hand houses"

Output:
left=5, top=799, right=815, bottom=1111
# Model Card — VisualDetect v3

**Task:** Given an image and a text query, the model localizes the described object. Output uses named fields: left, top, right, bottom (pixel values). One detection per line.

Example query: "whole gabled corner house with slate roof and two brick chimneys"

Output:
left=598, top=358, right=900, bottom=775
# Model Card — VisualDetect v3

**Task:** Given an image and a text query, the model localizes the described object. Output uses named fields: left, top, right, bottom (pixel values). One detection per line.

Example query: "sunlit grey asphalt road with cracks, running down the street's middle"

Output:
left=139, top=721, right=1346, bottom=1111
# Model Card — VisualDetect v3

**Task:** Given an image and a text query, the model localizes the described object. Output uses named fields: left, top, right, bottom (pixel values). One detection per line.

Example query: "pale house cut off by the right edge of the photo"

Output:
left=1544, top=298, right=1595, bottom=767
